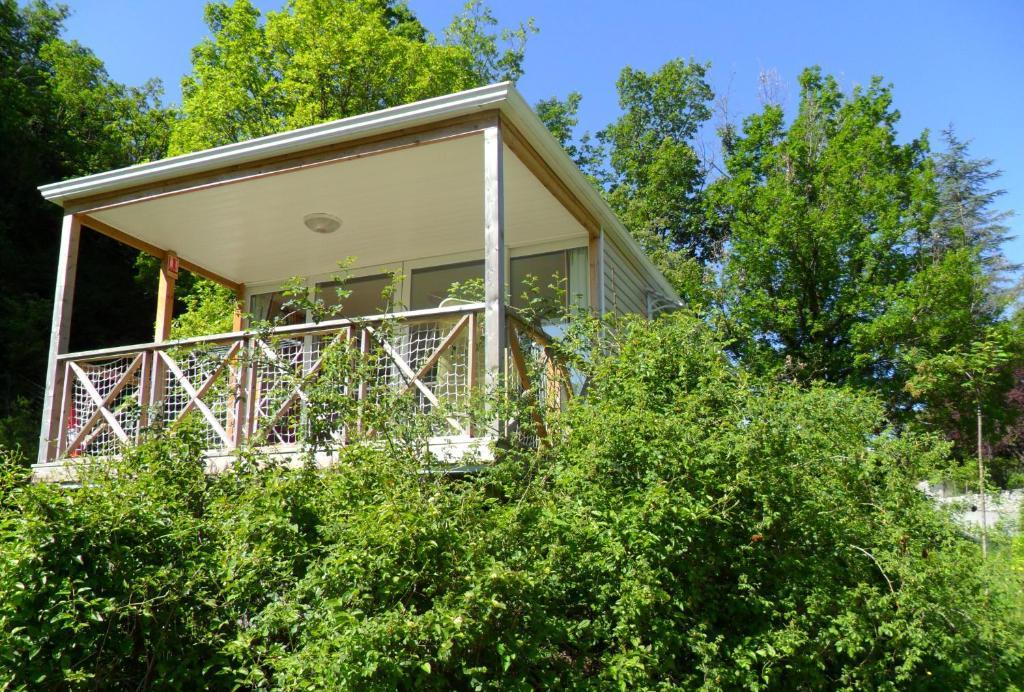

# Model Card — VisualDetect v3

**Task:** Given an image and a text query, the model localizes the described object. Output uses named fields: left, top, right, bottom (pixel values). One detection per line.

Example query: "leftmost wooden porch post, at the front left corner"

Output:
left=38, top=214, right=82, bottom=464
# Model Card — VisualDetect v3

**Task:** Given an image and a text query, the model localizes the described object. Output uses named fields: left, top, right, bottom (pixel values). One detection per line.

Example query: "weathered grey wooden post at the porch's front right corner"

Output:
left=483, top=123, right=508, bottom=391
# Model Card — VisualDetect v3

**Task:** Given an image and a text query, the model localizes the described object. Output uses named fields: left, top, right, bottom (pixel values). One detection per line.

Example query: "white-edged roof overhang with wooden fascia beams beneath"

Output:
left=39, top=82, right=678, bottom=300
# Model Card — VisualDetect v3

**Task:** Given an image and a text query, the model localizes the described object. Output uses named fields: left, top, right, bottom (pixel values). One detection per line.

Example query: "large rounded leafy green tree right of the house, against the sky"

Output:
left=712, top=69, right=934, bottom=382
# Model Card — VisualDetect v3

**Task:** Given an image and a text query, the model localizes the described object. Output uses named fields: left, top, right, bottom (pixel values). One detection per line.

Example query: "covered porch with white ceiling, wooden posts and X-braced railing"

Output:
left=37, top=85, right=602, bottom=472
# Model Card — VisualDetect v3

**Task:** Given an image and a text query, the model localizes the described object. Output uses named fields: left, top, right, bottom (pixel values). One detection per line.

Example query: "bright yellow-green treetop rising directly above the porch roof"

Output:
left=171, top=0, right=534, bottom=154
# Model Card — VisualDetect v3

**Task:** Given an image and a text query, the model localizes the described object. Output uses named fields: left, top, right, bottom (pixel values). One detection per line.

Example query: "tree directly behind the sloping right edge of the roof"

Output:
left=536, top=59, right=725, bottom=303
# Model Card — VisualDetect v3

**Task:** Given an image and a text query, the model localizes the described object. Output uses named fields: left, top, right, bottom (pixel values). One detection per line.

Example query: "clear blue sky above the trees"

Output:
left=58, top=0, right=1024, bottom=263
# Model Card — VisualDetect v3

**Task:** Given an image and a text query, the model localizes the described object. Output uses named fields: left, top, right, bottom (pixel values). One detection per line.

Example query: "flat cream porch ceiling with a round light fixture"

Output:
left=89, top=134, right=587, bottom=284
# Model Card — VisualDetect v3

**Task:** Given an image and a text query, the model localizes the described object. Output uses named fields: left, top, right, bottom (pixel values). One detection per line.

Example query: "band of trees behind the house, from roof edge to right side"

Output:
left=536, top=65, right=1024, bottom=472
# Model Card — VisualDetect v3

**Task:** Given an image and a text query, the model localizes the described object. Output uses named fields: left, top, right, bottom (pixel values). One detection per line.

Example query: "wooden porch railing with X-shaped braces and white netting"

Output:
left=44, top=303, right=570, bottom=461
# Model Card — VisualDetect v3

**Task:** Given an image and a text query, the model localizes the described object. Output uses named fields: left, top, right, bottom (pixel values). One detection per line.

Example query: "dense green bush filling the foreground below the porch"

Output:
left=0, top=315, right=1024, bottom=689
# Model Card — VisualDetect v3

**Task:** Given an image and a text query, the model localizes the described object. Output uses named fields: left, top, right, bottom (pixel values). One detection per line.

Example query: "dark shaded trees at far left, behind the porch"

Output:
left=0, top=0, right=170, bottom=456
